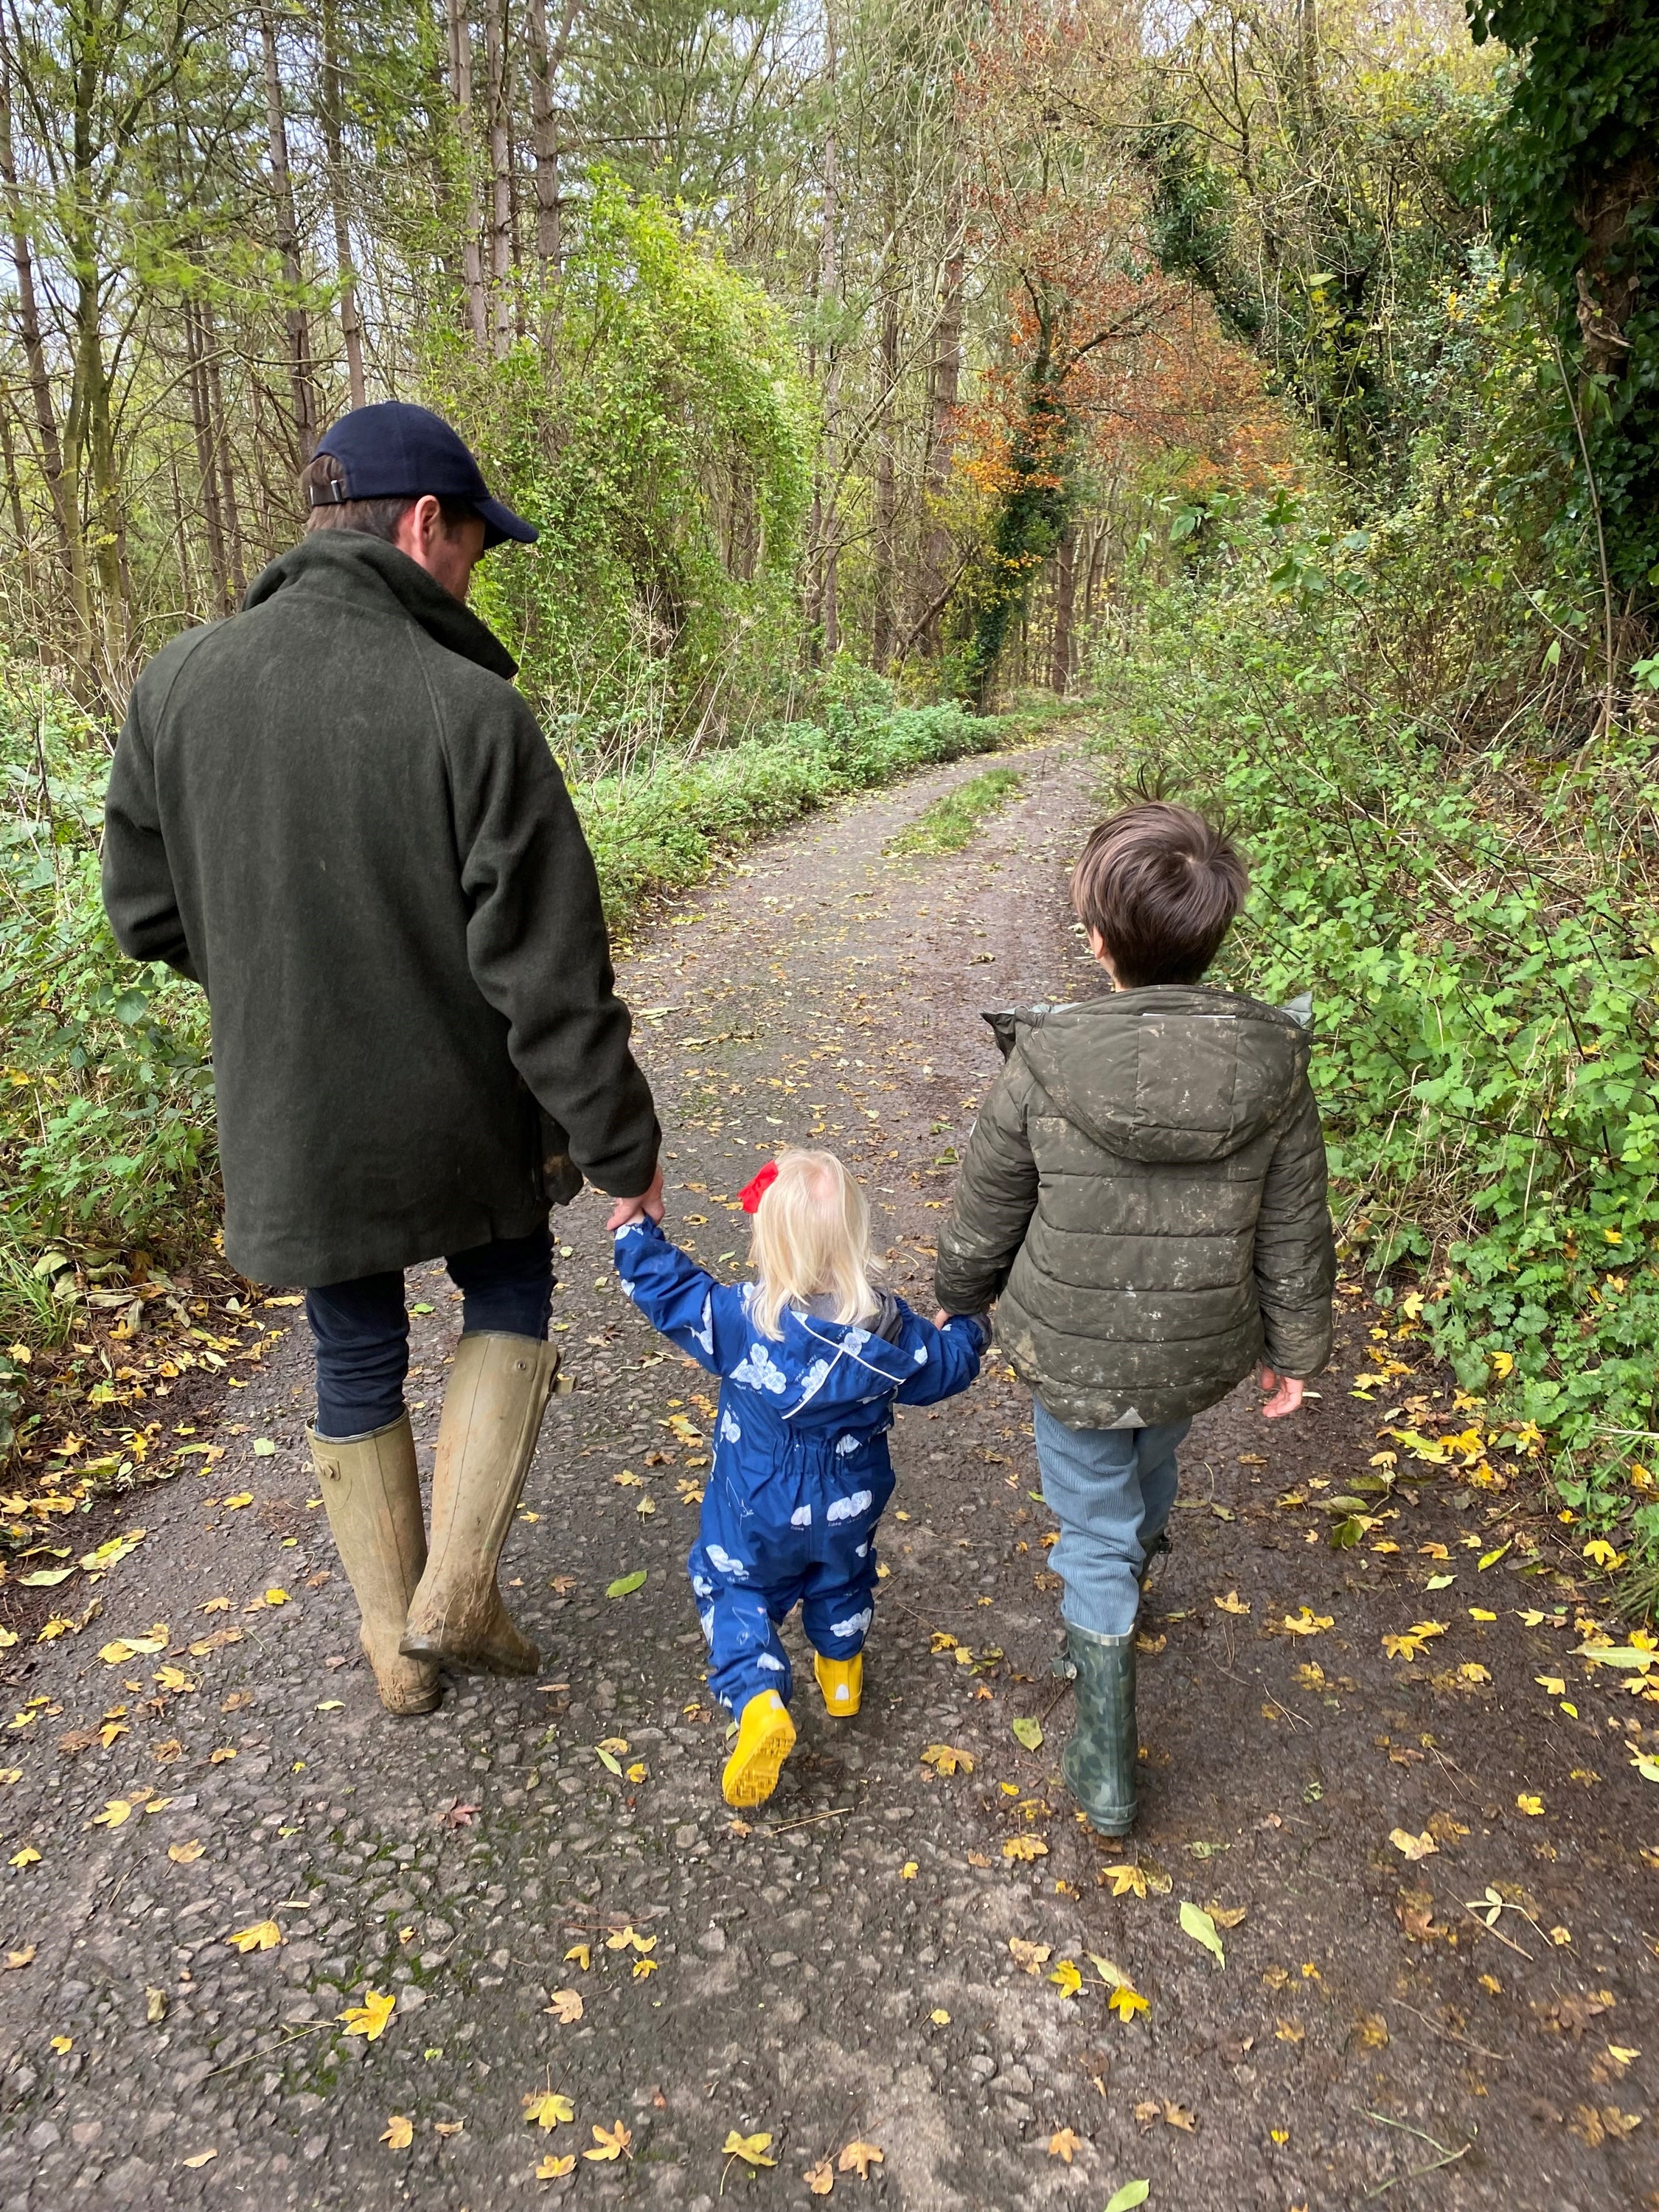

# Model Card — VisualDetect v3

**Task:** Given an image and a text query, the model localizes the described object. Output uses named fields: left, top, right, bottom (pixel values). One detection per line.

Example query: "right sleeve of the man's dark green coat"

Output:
left=449, top=686, right=659, bottom=1197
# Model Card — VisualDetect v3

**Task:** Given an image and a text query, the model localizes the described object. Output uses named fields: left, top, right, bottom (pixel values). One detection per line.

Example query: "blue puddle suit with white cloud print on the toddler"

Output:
left=615, top=1221, right=987, bottom=1712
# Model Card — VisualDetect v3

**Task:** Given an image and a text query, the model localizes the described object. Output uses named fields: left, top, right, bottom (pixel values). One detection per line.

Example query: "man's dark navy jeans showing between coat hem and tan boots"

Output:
left=305, top=1230, right=553, bottom=1440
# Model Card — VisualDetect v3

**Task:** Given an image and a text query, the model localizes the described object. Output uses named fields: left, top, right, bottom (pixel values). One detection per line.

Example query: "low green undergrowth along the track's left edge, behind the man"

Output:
left=0, top=661, right=1057, bottom=1458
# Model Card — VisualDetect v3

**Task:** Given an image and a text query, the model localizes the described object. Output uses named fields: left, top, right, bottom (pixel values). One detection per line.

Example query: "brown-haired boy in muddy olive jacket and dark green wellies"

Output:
left=936, top=803, right=1336, bottom=1836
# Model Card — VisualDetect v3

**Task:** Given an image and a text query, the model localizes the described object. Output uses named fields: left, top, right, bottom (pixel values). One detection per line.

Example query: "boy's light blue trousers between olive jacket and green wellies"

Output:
left=1031, top=1400, right=1192, bottom=1637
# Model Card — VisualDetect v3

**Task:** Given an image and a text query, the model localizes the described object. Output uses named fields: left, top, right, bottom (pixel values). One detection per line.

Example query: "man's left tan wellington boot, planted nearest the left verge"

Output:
left=305, top=1413, right=442, bottom=1712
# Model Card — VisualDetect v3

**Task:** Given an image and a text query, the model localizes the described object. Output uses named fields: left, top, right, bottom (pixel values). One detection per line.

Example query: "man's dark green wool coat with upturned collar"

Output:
left=104, top=531, right=657, bottom=1285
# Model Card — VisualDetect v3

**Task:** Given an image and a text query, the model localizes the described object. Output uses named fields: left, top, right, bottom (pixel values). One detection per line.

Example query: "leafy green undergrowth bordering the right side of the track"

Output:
left=1102, top=526, right=1659, bottom=1606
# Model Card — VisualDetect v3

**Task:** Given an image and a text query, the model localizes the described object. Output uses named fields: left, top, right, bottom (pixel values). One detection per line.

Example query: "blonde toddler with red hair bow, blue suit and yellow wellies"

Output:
left=615, top=1152, right=987, bottom=1805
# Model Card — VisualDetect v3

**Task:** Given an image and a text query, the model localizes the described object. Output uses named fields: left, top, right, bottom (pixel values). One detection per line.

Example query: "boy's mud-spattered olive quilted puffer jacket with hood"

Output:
left=936, top=987, right=1336, bottom=1429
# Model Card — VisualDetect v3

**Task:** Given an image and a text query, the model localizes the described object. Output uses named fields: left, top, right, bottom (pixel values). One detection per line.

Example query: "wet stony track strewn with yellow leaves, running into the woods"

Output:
left=0, top=748, right=1659, bottom=2212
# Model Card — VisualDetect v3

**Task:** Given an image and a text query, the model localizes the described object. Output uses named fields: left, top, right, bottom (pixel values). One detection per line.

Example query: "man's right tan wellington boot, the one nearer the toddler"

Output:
left=403, top=1329, right=560, bottom=1674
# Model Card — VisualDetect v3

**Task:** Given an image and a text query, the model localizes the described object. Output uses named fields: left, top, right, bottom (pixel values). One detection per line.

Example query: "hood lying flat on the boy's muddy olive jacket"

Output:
left=987, top=984, right=1307, bottom=1161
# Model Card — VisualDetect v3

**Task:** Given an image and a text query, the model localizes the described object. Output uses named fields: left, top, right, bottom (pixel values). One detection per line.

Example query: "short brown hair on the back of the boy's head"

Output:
left=1071, top=799, right=1250, bottom=991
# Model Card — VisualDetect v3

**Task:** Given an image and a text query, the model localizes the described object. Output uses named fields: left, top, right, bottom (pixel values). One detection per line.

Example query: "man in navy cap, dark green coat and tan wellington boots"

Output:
left=104, top=403, right=661, bottom=1712
